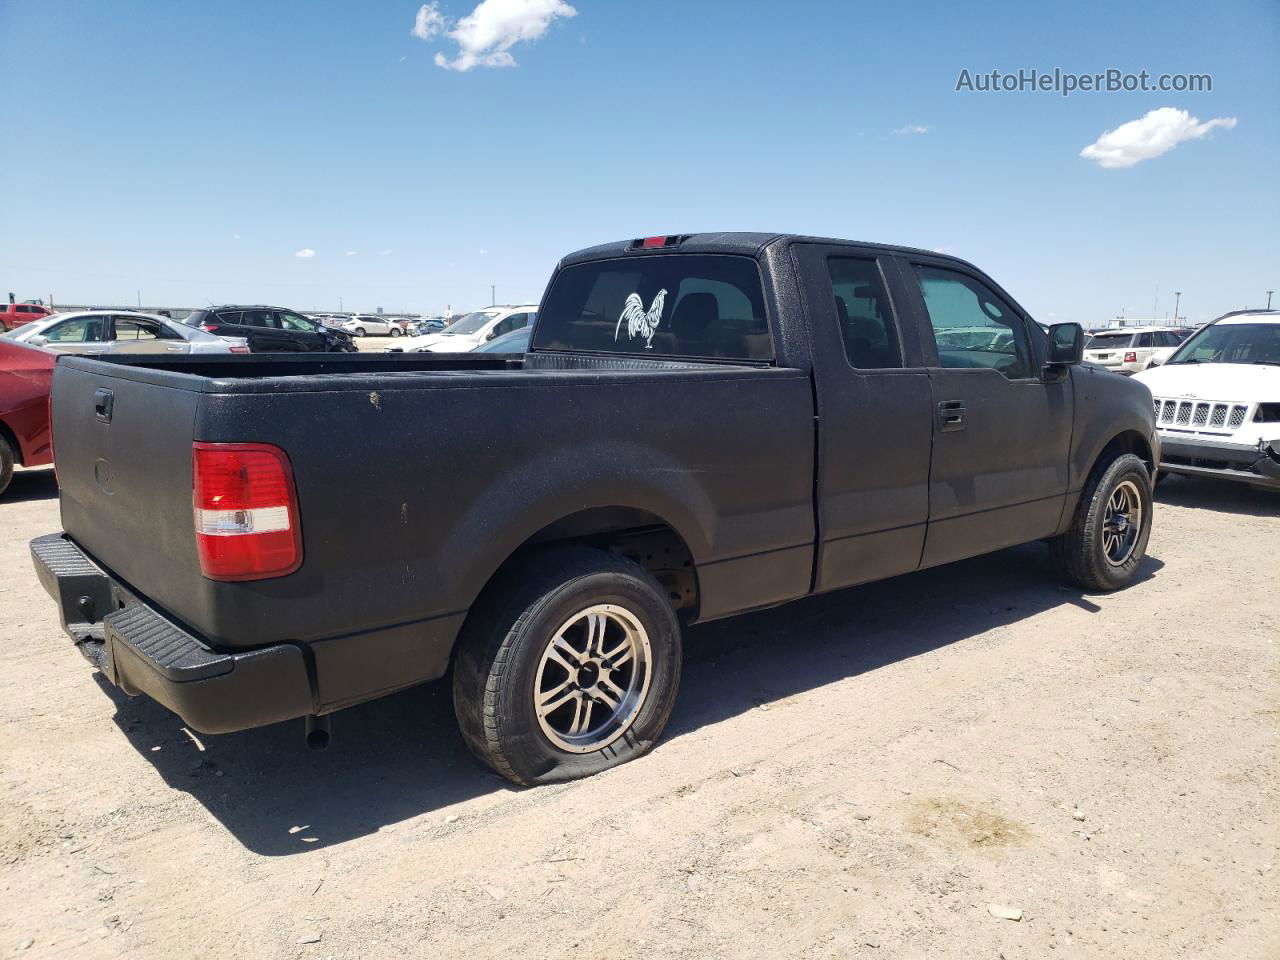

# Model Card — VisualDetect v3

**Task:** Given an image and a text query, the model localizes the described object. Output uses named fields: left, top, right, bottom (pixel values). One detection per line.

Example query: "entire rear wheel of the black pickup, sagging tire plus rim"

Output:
left=453, top=548, right=681, bottom=785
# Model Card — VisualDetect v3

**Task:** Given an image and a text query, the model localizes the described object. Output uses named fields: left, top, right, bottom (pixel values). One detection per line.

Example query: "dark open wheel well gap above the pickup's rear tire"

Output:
left=490, top=507, right=698, bottom=613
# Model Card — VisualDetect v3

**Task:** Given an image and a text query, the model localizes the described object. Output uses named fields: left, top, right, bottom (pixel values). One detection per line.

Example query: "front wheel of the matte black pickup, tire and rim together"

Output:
left=1050, top=453, right=1153, bottom=591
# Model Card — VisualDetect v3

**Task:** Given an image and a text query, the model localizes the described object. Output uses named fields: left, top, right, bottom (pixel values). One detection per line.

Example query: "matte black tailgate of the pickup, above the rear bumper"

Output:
left=52, top=360, right=201, bottom=624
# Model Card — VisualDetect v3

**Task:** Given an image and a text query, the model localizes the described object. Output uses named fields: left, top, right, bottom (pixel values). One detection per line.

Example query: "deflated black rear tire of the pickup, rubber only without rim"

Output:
left=453, top=548, right=681, bottom=786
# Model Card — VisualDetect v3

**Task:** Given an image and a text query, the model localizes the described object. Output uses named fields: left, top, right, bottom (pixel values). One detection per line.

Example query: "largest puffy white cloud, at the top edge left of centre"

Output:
left=424, top=0, right=577, bottom=72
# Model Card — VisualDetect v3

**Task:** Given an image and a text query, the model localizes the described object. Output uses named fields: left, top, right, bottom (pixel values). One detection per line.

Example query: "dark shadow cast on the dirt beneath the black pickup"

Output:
left=99, top=544, right=1164, bottom=856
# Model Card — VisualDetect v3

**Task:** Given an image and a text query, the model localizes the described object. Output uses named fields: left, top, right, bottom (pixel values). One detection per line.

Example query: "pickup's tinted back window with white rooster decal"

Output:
left=534, top=255, right=773, bottom=360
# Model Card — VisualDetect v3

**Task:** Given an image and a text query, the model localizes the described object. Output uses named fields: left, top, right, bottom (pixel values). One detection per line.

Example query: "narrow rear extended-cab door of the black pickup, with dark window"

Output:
left=792, top=243, right=933, bottom=590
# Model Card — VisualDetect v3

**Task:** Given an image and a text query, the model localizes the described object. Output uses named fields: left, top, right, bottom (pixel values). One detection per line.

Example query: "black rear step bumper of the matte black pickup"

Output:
left=31, top=534, right=316, bottom=733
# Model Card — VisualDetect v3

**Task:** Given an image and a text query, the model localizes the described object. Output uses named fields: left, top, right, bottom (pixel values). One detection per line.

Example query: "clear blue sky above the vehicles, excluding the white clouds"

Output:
left=0, top=0, right=1280, bottom=323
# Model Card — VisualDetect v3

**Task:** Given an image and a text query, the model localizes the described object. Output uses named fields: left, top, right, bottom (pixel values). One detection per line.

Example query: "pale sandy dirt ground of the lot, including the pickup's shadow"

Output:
left=0, top=470, right=1280, bottom=960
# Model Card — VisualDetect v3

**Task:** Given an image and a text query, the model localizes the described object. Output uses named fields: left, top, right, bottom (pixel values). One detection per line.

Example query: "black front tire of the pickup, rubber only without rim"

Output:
left=1048, top=453, right=1155, bottom=593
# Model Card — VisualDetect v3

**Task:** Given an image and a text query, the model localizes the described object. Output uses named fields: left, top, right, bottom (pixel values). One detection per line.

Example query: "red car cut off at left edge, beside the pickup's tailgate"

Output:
left=0, top=339, right=58, bottom=494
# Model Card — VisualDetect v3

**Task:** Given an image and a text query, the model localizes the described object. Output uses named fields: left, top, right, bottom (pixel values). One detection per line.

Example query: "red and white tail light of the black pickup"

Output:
left=192, top=443, right=302, bottom=580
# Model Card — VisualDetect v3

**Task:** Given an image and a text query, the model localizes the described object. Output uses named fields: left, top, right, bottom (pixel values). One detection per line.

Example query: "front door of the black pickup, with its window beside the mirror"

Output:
left=899, top=256, right=1074, bottom=566
